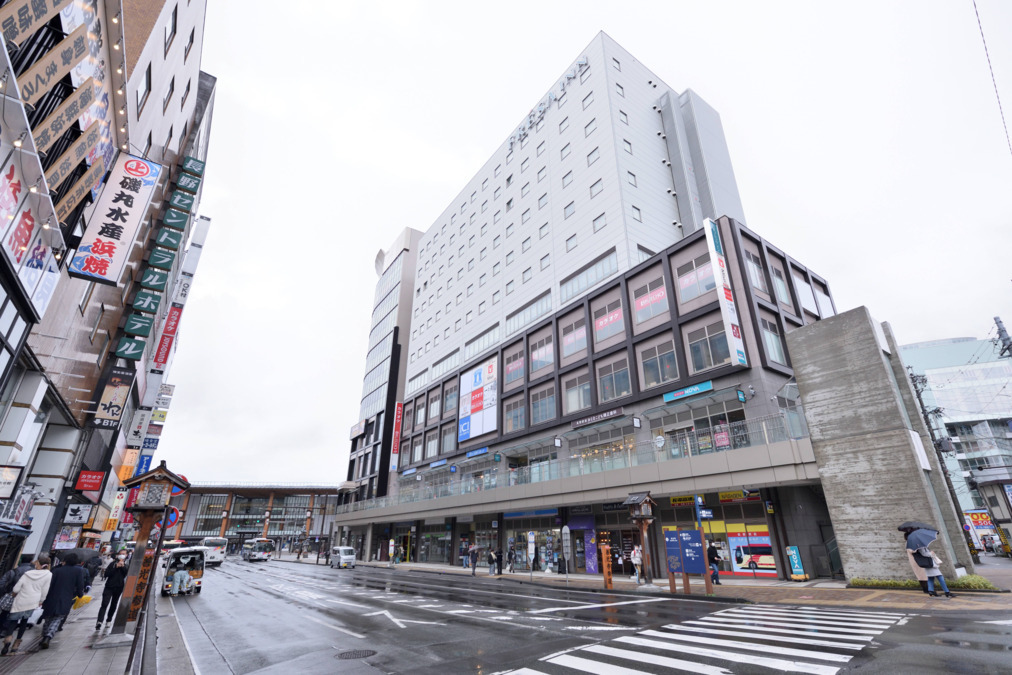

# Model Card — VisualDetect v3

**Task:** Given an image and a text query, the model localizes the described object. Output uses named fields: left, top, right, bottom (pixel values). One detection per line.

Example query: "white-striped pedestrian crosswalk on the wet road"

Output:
left=511, top=605, right=906, bottom=675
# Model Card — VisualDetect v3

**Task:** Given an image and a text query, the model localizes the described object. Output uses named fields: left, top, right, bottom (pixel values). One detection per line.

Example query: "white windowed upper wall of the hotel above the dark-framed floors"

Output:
left=405, top=32, right=741, bottom=396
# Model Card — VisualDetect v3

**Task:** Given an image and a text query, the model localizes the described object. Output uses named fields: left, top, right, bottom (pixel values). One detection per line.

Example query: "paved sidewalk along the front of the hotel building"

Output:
left=281, top=556, right=1012, bottom=611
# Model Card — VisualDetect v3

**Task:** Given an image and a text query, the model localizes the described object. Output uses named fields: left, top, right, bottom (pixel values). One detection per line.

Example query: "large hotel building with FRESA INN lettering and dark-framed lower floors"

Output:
left=335, top=33, right=838, bottom=575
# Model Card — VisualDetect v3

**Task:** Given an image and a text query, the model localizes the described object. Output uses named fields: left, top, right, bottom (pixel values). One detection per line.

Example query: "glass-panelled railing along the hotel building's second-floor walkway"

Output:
left=336, top=409, right=809, bottom=514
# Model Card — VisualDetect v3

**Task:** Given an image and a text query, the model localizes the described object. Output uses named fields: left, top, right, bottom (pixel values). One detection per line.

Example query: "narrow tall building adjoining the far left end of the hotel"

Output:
left=343, top=228, right=422, bottom=501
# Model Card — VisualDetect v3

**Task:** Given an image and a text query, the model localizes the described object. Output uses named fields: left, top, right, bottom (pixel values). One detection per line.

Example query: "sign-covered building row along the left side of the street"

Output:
left=0, top=0, right=216, bottom=566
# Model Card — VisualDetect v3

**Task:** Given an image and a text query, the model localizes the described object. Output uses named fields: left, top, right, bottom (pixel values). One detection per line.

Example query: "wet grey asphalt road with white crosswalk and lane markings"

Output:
left=173, top=561, right=1012, bottom=675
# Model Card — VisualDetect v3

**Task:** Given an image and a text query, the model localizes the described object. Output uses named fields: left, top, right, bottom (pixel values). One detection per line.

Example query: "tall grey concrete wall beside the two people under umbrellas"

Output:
left=787, top=307, right=973, bottom=579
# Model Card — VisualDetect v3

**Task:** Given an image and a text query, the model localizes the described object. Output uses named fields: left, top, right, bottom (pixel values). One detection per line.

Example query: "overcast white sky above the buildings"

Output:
left=156, top=0, right=1012, bottom=484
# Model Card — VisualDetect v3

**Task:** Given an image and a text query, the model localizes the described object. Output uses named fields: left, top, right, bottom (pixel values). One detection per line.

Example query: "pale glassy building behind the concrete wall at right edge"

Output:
left=900, top=338, right=1012, bottom=511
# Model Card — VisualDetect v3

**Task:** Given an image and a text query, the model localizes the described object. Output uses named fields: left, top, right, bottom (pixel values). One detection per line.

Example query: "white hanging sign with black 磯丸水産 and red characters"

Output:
left=67, top=154, right=164, bottom=286
